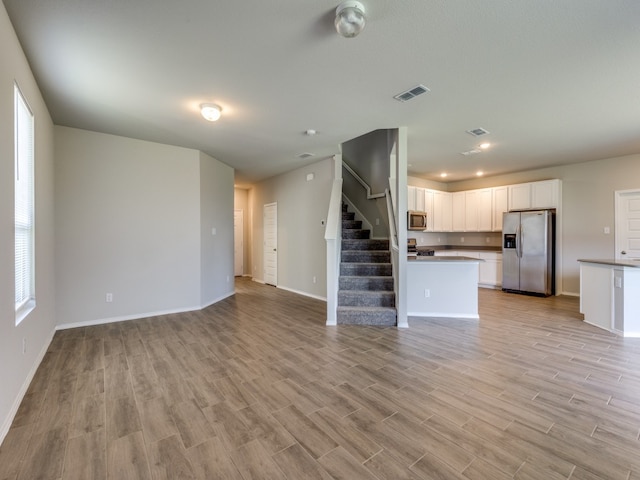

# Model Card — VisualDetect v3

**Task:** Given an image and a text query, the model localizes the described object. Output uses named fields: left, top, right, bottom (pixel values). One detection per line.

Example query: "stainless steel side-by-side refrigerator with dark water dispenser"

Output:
left=502, top=210, right=555, bottom=296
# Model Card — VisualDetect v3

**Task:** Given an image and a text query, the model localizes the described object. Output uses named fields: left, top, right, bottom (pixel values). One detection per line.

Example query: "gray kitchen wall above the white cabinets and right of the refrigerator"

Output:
left=436, top=154, right=640, bottom=294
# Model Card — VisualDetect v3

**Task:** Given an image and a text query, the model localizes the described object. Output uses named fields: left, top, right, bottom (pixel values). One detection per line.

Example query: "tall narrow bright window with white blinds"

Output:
left=14, top=85, right=36, bottom=325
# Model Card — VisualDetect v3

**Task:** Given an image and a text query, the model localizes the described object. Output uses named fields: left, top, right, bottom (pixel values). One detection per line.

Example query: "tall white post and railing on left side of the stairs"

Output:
left=324, top=178, right=342, bottom=325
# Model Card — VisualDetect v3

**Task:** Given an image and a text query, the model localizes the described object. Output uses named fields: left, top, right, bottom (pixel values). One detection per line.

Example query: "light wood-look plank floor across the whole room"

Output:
left=0, top=279, right=640, bottom=480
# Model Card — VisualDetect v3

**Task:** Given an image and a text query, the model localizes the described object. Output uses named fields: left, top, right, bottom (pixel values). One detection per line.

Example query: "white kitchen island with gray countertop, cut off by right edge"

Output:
left=578, top=259, right=640, bottom=337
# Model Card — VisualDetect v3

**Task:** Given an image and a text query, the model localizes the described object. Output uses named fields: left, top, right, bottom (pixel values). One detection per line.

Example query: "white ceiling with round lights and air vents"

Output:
left=3, top=0, right=640, bottom=183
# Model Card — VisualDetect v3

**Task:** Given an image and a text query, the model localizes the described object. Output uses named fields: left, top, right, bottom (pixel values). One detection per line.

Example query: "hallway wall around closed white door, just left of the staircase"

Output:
left=249, top=159, right=333, bottom=299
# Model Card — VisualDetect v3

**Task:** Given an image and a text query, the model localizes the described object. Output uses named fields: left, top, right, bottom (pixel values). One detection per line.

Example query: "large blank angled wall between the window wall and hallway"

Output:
left=56, top=127, right=233, bottom=326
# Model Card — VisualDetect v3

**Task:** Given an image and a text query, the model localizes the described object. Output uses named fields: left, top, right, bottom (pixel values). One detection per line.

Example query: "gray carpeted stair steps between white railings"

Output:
left=337, top=204, right=396, bottom=326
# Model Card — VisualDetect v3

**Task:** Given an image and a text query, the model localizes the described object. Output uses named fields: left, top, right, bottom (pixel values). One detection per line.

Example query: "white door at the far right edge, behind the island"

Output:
left=616, top=190, right=640, bottom=260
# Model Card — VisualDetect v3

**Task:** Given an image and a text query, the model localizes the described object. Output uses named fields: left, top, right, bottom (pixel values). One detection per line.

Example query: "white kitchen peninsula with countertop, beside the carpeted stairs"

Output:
left=407, top=256, right=483, bottom=319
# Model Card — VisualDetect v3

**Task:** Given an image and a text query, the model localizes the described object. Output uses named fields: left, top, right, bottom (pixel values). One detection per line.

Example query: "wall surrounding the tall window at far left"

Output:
left=0, top=2, right=56, bottom=442
